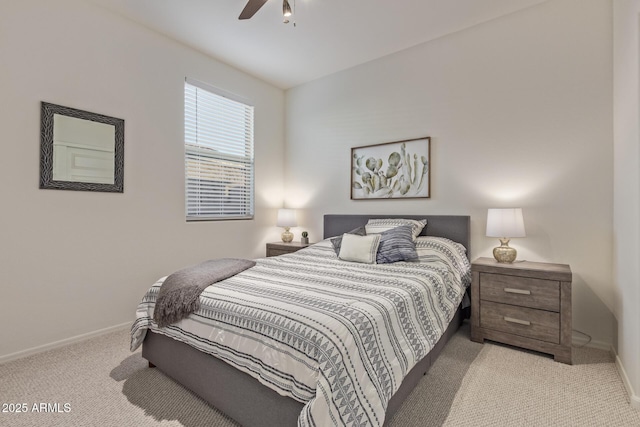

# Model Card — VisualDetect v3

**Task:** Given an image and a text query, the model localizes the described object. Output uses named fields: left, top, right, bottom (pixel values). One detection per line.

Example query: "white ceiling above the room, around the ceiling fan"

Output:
left=90, top=0, right=548, bottom=89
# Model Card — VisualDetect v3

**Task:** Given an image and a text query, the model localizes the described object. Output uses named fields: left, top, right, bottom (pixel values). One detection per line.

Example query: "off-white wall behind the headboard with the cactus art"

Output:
left=285, top=0, right=615, bottom=347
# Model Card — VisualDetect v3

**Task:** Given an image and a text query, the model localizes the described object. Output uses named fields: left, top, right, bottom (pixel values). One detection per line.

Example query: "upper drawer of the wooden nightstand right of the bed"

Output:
left=480, top=273, right=560, bottom=312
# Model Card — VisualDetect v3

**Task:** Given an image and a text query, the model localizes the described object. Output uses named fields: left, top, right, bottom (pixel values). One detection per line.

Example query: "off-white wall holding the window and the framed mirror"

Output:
left=0, top=0, right=284, bottom=360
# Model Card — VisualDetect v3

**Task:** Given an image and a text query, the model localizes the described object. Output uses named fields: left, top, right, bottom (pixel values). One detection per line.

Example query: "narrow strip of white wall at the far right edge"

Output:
left=613, top=0, right=640, bottom=408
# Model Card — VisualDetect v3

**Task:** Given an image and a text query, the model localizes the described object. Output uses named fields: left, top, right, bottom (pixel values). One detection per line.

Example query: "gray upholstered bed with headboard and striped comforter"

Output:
left=132, top=215, right=470, bottom=426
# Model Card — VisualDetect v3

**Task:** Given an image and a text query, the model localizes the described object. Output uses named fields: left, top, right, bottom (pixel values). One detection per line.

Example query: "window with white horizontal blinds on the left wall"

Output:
left=184, top=79, right=254, bottom=221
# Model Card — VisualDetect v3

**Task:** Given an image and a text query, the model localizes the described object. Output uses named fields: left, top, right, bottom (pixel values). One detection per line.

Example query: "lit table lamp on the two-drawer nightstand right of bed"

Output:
left=487, top=208, right=526, bottom=264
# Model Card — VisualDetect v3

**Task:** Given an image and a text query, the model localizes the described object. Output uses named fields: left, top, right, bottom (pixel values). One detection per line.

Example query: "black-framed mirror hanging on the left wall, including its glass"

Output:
left=40, top=102, right=124, bottom=193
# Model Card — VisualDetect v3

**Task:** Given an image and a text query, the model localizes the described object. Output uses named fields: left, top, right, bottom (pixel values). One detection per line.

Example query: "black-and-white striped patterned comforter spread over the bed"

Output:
left=131, top=240, right=469, bottom=426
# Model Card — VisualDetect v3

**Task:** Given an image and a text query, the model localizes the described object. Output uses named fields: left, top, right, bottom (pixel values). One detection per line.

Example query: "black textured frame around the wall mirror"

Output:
left=40, top=101, right=124, bottom=193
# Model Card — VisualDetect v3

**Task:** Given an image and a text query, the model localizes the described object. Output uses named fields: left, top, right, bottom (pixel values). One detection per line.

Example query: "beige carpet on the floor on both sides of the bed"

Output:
left=0, top=324, right=640, bottom=427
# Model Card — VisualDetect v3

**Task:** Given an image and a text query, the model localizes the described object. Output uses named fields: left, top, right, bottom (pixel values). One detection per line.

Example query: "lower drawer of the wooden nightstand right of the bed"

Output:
left=480, top=301, right=560, bottom=344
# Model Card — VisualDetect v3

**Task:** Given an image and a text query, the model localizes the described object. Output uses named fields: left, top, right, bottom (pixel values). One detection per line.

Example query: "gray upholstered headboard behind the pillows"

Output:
left=324, top=215, right=471, bottom=258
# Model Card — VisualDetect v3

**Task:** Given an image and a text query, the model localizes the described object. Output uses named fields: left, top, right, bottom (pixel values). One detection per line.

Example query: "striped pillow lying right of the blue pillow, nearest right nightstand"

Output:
left=416, top=236, right=471, bottom=286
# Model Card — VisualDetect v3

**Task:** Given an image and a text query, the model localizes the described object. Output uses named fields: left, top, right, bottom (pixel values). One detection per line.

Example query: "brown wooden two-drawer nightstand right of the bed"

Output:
left=471, top=258, right=571, bottom=364
